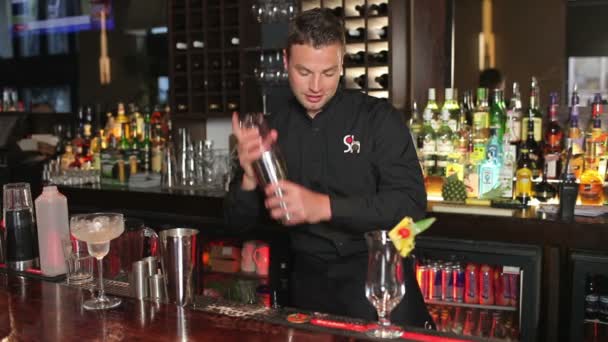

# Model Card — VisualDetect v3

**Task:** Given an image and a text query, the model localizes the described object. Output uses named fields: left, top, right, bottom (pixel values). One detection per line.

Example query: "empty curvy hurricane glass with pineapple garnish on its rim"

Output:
left=365, top=230, right=405, bottom=338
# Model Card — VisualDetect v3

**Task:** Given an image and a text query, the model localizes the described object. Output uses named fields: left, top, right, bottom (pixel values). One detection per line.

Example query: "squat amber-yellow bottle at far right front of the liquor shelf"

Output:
left=578, top=141, right=604, bottom=205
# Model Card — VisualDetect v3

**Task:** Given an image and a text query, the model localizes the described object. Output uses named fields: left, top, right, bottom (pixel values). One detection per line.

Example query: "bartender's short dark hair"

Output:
left=287, top=8, right=346, bottom=56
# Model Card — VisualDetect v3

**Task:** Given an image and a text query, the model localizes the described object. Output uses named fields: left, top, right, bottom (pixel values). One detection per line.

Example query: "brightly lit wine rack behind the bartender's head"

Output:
left=301, top=0, right=394, bottom=100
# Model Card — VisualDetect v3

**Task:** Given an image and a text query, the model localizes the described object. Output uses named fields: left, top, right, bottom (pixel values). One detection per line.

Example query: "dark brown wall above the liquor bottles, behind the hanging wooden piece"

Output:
left=455, top=0, right=578, bottom=105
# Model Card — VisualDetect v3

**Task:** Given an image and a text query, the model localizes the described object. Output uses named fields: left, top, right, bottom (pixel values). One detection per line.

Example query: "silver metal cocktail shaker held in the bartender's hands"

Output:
left=242, top=113, right=289, bottom=220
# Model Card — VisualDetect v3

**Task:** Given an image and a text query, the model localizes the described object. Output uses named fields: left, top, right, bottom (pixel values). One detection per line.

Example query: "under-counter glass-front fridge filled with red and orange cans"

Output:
left=414, top=237, right=542, bottom=341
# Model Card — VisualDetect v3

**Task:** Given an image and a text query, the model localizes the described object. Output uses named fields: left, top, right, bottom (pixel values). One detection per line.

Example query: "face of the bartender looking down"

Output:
left=283, top=43, right=343, bottom=117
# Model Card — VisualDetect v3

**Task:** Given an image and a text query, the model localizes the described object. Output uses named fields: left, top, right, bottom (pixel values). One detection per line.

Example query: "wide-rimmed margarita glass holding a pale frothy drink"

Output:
left=70, top=213, right=125, bottom=310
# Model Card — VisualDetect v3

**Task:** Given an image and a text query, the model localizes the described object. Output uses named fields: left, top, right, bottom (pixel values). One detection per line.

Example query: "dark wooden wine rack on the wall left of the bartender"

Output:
left=168, top=0, right=242, bottom=118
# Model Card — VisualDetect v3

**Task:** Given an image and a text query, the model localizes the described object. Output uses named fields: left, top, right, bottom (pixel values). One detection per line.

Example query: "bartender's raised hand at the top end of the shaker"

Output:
left=232, top=112, right=277, bottom=190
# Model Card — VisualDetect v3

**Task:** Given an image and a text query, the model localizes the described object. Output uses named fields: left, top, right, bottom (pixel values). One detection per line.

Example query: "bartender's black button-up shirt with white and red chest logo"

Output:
left=225, top=90, right=426, bottom=259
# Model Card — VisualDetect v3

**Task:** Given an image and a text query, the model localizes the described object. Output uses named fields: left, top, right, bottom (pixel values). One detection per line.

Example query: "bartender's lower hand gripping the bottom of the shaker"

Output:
left=264, top=180, right=331, bottom=226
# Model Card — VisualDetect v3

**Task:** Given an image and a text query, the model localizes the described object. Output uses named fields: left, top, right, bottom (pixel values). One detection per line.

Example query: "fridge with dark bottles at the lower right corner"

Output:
left=569, top=250, right=608, bottom=342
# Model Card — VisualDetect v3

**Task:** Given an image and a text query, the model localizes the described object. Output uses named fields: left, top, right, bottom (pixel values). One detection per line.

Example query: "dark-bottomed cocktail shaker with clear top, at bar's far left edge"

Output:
left=2, top=183, right=38, bottom=271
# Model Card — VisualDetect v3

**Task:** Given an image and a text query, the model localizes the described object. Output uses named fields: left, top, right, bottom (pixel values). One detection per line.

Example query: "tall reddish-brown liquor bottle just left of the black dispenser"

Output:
left=543, top=93, right=564, bottom=179
